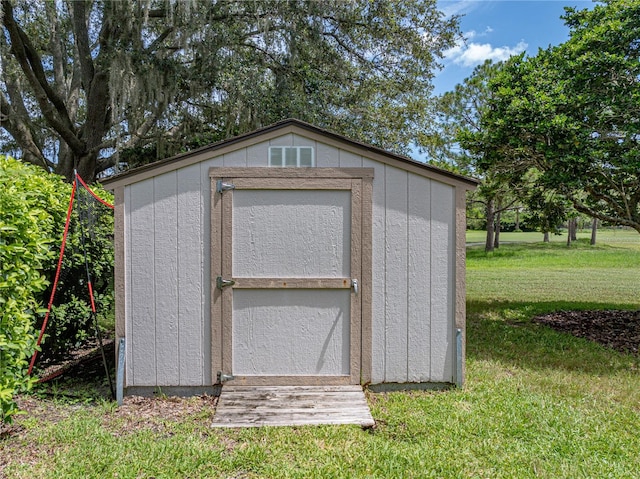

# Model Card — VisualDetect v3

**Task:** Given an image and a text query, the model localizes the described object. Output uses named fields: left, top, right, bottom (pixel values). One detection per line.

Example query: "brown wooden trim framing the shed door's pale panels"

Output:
left=209, top=167, right=374, bottom=385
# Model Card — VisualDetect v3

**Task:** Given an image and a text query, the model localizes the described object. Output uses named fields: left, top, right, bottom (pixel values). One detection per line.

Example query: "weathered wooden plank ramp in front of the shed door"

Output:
left=212, top=385, right=375, bottom=428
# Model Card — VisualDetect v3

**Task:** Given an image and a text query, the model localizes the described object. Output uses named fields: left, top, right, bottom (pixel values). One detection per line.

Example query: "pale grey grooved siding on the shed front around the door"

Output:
left=124, top=133, right=456, bottom=387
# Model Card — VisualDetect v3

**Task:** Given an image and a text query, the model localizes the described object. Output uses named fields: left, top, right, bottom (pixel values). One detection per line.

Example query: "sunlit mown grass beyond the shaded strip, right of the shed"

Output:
left=467, top=230, right=640, bottom=311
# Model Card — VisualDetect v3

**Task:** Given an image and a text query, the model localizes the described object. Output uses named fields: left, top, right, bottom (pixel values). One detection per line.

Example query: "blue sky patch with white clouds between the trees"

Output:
left=434, top=0, right=594, bottom=94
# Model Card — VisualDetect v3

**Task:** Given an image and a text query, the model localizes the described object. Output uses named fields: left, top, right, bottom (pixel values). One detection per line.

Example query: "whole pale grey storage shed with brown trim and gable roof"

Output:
left=103, top=120, right=476, bottom=395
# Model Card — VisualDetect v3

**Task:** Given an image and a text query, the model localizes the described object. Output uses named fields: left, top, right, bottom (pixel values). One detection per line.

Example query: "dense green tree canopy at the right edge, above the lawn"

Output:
left=462, top=0, right=640, bottom=232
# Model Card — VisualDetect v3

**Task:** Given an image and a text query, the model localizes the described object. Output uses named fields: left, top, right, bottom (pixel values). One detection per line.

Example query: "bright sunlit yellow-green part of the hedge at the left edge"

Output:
left=0, top=156, right=55, bottom=422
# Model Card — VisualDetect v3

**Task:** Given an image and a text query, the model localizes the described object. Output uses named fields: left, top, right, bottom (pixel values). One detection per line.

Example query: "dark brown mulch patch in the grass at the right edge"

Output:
left=533, top=311, right=640, bottom=355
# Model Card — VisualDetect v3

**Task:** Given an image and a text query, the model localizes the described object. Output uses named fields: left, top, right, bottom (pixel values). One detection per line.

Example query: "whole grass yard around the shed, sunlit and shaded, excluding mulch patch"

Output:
left=0, top=231, right=640, bottom=479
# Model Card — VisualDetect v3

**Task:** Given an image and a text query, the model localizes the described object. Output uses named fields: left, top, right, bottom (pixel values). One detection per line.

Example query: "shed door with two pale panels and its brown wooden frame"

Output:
left=211, top=168, right=366, bottom=385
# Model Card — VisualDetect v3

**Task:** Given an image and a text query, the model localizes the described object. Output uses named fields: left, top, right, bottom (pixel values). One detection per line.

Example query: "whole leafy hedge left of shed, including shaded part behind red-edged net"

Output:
left=0, top=156, right=113, bottom=422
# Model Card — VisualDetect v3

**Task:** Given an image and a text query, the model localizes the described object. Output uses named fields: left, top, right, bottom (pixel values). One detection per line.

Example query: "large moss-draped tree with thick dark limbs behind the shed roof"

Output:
left=0, top=0, right=459, bottom=179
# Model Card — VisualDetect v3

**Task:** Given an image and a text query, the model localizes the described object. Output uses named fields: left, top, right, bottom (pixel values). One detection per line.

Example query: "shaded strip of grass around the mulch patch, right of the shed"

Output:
left=467, top=301, right=640, bottom=376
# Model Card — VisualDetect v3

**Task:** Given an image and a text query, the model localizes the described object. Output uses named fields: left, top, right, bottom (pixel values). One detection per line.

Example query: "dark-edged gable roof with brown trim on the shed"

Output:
left=100, top=119, right=479, bottom=189
